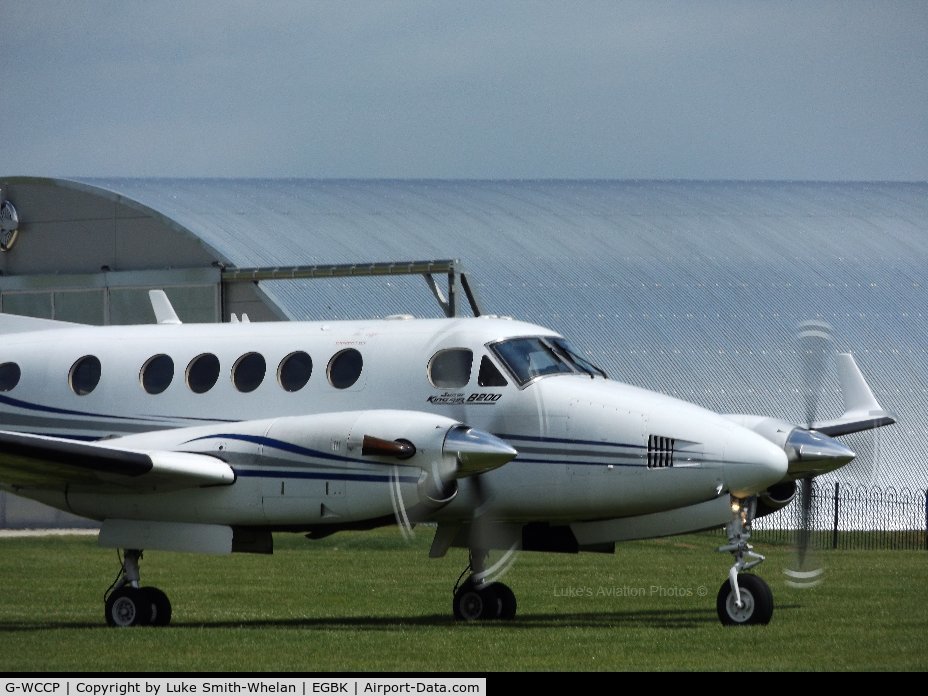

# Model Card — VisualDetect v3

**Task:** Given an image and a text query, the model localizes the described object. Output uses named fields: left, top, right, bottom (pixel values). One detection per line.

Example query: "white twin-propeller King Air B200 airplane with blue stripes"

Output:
left=0, top=291, right=893, bottom=626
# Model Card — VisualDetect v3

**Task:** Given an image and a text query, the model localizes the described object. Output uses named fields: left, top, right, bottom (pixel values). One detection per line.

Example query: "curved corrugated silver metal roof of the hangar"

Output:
left=65, top=179, right=928, bottom=486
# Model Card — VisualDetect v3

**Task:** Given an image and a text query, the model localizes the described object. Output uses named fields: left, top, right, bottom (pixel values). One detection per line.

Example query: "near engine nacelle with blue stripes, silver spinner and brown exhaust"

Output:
left=90, top=409, right=518, bottom=526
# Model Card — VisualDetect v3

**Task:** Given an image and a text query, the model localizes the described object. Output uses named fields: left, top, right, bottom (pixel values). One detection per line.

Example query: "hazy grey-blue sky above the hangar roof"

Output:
left=0, top=0, right=928, bottom=181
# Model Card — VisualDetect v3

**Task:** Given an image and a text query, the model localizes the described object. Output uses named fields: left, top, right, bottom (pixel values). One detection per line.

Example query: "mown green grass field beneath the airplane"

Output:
left=0, top=529, right=928, bottom=673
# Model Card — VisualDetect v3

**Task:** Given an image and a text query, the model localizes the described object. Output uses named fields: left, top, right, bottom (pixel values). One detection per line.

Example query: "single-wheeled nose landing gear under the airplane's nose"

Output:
left=715, top=497, right=773, bottom=626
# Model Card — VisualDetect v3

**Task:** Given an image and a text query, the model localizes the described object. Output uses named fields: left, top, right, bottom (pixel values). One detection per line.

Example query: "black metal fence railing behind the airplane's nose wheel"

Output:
left=754, top=480, right=928, bottom=550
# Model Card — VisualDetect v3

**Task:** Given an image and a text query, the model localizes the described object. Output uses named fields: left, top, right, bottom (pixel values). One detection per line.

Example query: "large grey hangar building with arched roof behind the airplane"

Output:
left=0, top=176, right=928, bottom=527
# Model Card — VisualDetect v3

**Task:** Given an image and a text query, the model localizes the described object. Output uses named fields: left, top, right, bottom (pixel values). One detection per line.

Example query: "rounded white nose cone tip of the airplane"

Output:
left=725, top=428, right=789, bottom=498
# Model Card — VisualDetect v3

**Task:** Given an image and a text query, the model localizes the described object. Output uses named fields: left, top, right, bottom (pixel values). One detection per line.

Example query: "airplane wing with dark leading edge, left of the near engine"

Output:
left=0, top=431, right=235, bottom=493
